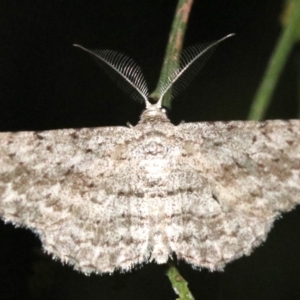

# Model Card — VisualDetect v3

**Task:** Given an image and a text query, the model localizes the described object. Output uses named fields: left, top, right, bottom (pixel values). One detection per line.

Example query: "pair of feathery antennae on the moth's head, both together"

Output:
left=74, top=34, right=234, bottom=108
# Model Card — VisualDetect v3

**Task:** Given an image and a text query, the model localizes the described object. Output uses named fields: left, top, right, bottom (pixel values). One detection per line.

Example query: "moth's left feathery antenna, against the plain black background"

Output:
left=73, top=44, right=151, bottom=107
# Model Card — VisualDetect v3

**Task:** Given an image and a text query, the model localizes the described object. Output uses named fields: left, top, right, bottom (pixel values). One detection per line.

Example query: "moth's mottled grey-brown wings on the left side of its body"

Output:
left=0, top=127, right=147, bottom=273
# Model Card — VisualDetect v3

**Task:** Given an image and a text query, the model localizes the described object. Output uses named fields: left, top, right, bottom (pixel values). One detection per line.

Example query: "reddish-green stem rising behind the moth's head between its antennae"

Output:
left=150, top=0, right=194, bottom=108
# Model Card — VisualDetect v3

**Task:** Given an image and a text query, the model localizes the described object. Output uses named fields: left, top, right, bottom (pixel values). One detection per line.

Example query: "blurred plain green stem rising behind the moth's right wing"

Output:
left=248, top=0, right=300, bottom=120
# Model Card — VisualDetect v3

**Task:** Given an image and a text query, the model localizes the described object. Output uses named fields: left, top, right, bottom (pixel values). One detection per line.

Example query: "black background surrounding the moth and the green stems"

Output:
left=0, top=0, right=300, bottom=300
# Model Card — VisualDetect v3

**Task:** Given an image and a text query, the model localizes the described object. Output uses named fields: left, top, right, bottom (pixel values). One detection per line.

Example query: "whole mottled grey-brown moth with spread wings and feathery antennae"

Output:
left=0, top=36, right=300, bottom=274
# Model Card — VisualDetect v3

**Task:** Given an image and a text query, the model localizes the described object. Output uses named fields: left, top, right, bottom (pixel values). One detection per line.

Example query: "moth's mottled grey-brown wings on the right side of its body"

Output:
left=171, top=120, right=300, bottom=269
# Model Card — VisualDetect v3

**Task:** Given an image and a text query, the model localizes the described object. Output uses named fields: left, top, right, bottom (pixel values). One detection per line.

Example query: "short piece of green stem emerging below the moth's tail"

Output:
left=166, top=263, right=195, bottom=300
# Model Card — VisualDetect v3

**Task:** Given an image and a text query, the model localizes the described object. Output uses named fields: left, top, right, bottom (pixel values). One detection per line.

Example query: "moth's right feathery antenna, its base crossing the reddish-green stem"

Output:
left=157, top=33, right=234, bottom=106
